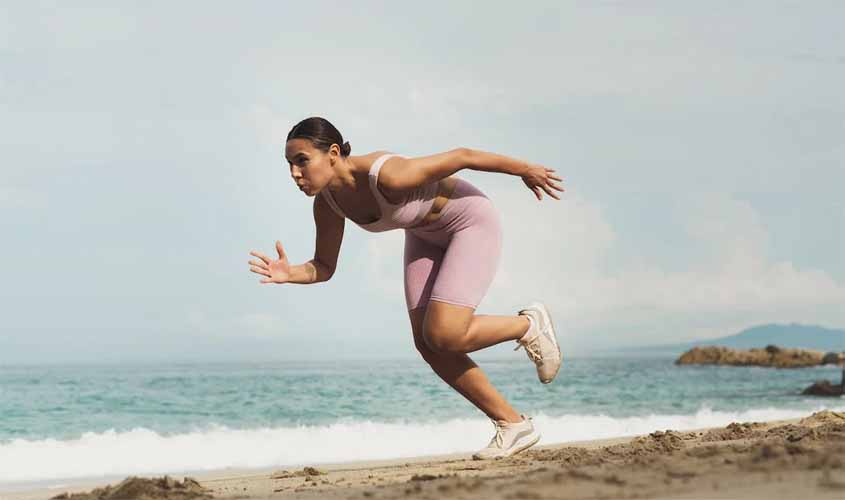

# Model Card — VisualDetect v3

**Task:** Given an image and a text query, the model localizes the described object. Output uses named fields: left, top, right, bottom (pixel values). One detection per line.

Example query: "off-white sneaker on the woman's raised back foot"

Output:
left=514, top=302, right=563, bottom=384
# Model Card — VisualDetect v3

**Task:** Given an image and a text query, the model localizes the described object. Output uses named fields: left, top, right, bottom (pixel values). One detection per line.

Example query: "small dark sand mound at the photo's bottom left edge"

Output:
left=50, top=476, right=212, bottom=500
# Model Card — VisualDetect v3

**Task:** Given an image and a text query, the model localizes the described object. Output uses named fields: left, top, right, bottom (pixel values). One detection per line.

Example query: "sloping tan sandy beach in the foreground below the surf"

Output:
left=0, top=411, right=845, bottom=500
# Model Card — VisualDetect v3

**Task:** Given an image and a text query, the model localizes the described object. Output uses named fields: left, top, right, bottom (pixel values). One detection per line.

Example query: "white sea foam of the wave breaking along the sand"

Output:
left=0, top=406, right=845, bottom=484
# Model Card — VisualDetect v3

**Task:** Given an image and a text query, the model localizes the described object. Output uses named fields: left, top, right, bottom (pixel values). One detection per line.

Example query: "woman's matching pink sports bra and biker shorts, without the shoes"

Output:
left=320, top=154, right=502, bottom=311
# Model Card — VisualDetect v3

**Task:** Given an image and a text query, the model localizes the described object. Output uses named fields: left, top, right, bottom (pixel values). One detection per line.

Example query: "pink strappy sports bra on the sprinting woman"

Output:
left=320, top=154, right=437, bottom=233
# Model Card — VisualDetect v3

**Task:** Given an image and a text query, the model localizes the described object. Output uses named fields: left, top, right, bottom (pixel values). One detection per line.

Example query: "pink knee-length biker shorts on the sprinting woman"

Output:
left=405, top=178, right=502, bottom=311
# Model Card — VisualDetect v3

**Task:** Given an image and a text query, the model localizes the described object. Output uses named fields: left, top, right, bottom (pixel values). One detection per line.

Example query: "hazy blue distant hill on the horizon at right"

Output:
left=626, top=323, right=845, bottom=354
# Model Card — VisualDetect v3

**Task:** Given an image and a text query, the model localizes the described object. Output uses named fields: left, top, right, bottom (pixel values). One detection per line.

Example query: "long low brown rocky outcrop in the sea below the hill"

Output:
left=675, top=345, right=845, bottom=368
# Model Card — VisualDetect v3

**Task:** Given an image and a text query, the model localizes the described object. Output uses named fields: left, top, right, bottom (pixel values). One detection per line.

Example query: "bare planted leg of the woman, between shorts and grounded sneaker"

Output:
left=408, top=306, right=522, bottom=422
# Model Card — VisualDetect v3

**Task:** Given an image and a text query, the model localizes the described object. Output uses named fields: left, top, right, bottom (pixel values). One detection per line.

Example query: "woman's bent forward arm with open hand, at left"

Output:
left=249, top=195, right=345, bottom=285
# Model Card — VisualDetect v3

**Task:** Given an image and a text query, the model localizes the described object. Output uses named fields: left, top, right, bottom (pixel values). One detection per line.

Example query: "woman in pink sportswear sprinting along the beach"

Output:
left=249, top=117, right=563, bottom=459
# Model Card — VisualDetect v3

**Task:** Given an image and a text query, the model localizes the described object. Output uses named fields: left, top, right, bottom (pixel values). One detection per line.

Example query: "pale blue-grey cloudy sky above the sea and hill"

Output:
left=0, top=1, right=845, bottom=364
